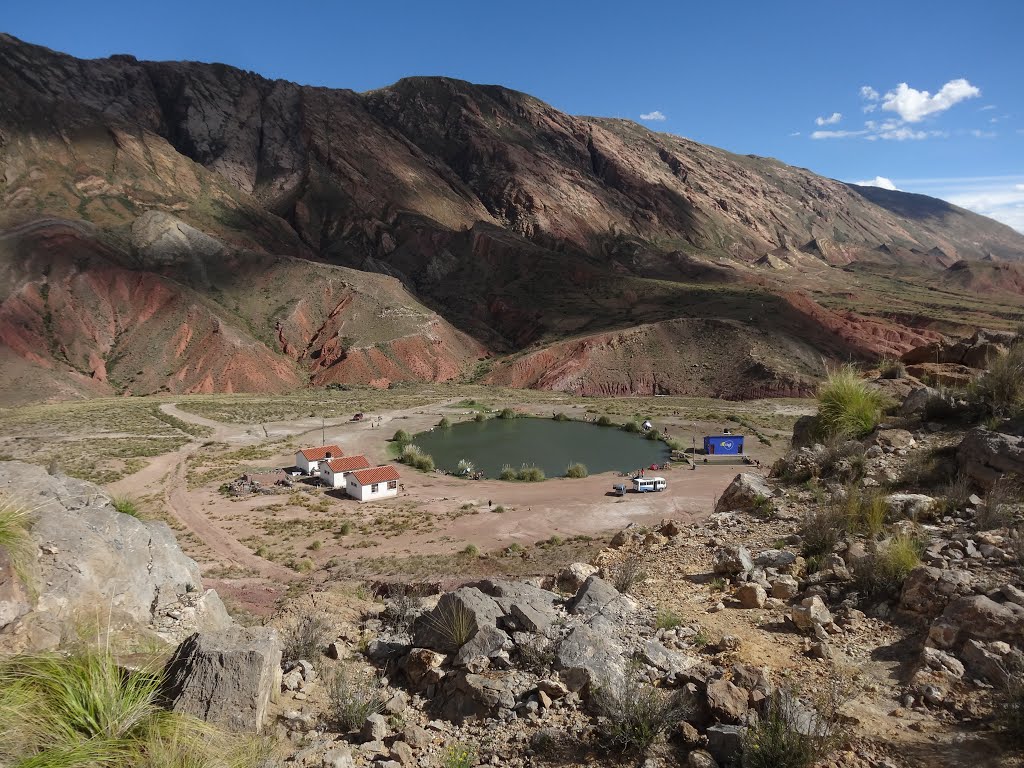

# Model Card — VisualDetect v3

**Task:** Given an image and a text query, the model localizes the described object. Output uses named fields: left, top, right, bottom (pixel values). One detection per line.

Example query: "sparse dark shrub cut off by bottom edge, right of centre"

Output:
left=742, top=688, right=842, bottom=768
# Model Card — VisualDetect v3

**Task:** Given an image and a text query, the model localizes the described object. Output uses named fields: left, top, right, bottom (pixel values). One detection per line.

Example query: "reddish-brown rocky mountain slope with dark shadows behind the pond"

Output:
left=0, top=30, right=1024, bottom=397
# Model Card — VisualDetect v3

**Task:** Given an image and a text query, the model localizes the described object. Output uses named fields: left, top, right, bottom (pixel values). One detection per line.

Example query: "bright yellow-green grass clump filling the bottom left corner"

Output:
left=0, top=649, right=263, bottom=768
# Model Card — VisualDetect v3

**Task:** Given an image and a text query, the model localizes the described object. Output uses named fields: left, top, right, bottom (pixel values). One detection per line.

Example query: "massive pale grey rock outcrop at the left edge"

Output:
left=0, top=462, right=232, bottom=649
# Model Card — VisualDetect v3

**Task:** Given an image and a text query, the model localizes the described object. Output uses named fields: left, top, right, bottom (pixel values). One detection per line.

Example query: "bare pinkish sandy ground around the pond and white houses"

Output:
left=110, top=401, right=777, bottom=602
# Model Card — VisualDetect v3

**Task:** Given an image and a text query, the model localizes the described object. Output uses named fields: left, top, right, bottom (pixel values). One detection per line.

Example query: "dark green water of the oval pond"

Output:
left=413, top=418, right=670, bottom=478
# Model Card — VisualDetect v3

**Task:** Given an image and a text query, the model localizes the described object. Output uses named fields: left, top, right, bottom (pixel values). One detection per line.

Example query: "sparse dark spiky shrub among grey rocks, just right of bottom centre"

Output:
left=592, top=670, right=692, bottom=755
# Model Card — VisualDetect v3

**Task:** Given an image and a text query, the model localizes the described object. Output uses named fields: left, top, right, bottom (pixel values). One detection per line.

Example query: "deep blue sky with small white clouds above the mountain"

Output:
left=8, top=0, right=1024, bottom=231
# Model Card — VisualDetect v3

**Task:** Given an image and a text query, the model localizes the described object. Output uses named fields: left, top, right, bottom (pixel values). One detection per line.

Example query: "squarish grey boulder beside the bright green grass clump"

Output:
left=163, top=627, right=281, bottom=733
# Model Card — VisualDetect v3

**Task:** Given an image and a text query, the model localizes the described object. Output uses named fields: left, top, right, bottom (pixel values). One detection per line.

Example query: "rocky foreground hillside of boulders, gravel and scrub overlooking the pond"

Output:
left=0, top=380, right=1024, bottom=768
